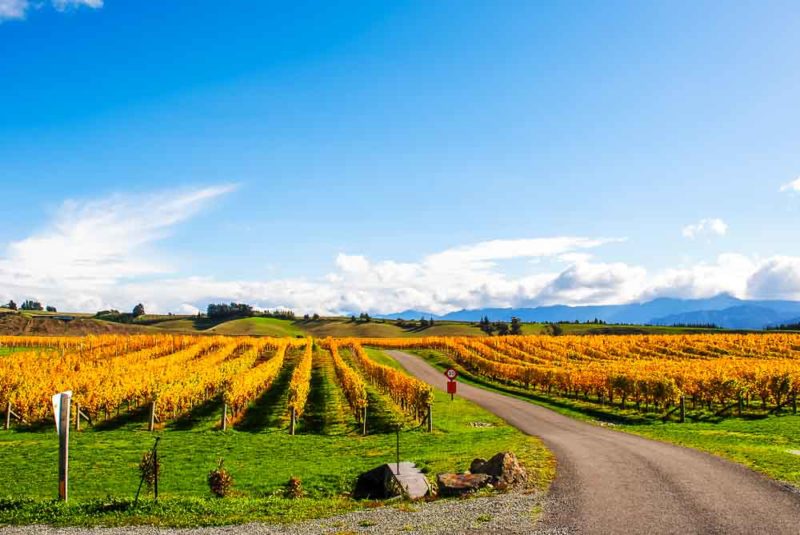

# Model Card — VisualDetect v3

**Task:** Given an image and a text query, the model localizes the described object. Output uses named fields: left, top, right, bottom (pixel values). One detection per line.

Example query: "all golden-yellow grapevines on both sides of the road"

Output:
left=0, top=334, right=800, bottom=432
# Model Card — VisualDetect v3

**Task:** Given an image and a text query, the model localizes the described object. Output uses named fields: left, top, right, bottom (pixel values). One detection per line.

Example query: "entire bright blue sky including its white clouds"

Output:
left=0, top=0, right=800, bottom=313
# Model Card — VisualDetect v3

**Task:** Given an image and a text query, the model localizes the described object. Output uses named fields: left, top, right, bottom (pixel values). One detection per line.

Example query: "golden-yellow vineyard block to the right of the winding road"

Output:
left=361, top=334, right=800, bottom=415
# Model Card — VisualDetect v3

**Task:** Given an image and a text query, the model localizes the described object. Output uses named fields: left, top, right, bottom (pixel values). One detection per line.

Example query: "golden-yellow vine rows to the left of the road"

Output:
left=0, top=334, right=433, bottom=434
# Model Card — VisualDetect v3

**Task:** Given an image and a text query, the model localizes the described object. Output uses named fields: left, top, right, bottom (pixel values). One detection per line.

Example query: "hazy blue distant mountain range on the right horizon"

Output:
left=378, top=294, right=800, bottom=329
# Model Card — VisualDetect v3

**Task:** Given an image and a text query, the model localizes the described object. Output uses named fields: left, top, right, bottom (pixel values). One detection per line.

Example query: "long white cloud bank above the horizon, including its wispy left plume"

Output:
left=0, top=186, right=800, bottom=314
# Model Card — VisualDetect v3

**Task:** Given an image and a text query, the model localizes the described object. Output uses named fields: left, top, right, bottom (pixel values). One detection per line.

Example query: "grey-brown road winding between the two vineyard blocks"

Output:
left=388, top=351, right=800, bottom=535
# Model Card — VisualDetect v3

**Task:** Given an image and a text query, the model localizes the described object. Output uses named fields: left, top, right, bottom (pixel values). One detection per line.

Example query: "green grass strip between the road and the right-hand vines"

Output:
left=411, top=350, right=800, bottom=487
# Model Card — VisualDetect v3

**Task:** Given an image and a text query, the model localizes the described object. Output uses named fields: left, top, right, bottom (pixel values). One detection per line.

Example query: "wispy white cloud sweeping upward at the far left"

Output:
left=0, top=185, right=234, bottom=306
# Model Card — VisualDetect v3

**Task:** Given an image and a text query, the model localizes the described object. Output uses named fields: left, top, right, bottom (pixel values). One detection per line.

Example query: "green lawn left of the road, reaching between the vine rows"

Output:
left=0, top=350, right=554, bottom=526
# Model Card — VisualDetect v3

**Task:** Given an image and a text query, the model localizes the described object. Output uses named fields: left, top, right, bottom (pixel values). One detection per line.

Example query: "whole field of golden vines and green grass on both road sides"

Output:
left=0, top=336, right=800, bottom=525
